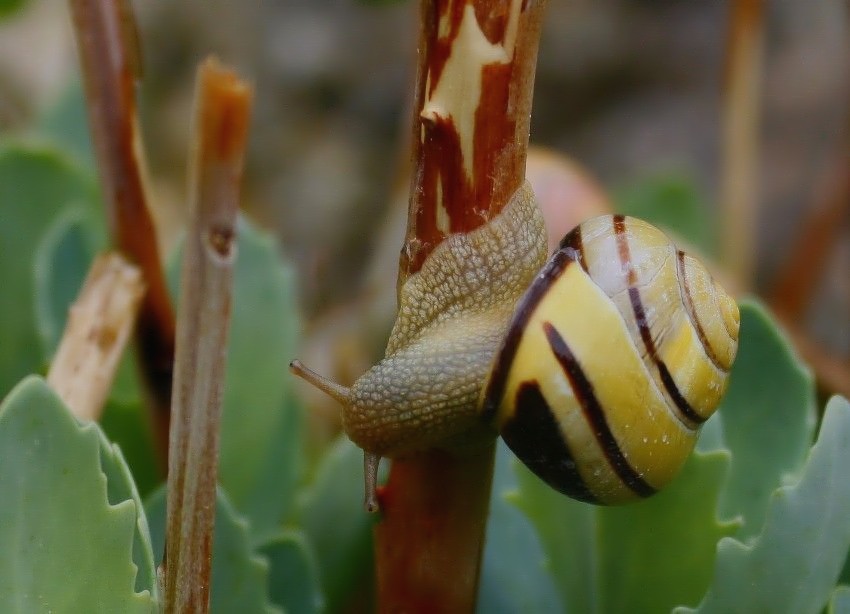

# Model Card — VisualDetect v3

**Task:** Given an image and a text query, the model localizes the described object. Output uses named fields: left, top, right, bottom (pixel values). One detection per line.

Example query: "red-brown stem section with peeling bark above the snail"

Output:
left=400, top=0, right=545, bottom=279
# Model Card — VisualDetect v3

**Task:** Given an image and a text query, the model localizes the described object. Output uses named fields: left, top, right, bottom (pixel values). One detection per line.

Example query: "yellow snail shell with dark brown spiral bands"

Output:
left=481, top=215, right=739, bottom=504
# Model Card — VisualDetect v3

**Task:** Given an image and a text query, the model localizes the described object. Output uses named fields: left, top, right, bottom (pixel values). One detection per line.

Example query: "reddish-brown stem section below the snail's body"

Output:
left=376, top=445, right=493, bottom=612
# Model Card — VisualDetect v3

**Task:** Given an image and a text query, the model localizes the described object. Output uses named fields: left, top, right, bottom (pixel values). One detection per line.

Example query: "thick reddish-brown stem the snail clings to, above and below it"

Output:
left=375, top=0, right=545, bottom=612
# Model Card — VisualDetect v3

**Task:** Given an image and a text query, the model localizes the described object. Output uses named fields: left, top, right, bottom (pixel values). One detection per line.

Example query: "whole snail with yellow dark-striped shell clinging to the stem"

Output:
left=290, top=183, right=739, bottom=511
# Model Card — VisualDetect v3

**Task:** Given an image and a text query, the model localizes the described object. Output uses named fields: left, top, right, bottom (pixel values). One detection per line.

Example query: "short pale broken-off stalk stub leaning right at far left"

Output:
left=47, top=253, right=145, bottom=420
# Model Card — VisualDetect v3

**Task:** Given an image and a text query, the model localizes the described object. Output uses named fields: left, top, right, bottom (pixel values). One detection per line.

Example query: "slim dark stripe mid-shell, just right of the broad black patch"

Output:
left=543, top=322, right=656, bottom=497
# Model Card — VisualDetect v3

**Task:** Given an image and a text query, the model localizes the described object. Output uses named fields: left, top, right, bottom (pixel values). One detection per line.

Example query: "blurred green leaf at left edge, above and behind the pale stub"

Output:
left=0, top=144, right=98, bottom=396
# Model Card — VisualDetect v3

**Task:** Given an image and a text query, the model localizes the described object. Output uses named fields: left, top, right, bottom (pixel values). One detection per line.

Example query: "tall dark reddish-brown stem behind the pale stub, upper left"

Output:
left=69, top=0, right=174, bottom=468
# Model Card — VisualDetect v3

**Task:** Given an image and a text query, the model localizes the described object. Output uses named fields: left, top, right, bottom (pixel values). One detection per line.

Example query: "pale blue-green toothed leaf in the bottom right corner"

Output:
left=677, top=397, right=850, bottom=613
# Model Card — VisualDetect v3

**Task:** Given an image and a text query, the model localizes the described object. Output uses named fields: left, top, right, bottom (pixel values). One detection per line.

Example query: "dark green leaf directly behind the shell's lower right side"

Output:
left=719, top=301, right=815, bottom=538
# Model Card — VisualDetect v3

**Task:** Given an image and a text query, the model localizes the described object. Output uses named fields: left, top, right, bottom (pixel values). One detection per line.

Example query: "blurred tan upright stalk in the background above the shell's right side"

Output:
left=720, top=0, right=764, bottom=288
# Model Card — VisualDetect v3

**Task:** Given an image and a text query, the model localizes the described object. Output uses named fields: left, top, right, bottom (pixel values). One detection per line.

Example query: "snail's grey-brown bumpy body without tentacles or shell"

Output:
left=343, top=183, right=546, bottom=457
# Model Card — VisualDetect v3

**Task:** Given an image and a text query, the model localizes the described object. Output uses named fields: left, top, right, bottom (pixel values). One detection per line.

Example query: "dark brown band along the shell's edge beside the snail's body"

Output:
left=481, top=250, right=573, bottom=422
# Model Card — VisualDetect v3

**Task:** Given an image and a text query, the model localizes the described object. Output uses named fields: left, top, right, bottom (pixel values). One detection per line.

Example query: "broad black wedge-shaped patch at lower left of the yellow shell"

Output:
left=502, top=381, right=598, bottom=503
